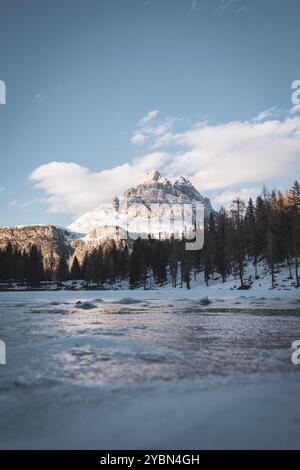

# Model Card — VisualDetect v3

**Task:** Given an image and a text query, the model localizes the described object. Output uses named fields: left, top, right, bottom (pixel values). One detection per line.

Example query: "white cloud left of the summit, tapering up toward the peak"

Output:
left=30, top=152, right=169, bottom=215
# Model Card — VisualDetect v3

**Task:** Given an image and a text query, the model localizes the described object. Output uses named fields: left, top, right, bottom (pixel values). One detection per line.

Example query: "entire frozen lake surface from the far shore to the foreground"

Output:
left=0, top=290, right=300, bottom=449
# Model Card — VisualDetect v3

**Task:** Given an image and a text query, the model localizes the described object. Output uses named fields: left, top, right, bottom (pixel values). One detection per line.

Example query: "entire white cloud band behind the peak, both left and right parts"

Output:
left=31, top=110, right=300, bottom=215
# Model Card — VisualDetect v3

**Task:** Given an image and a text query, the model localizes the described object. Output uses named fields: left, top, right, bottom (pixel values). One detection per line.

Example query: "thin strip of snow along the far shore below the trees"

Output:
left=0, top=286, right=300, bottom=309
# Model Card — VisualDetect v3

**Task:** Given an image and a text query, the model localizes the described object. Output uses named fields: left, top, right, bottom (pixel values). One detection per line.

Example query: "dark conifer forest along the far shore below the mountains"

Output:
left=0, top=181, right=300, bottom=289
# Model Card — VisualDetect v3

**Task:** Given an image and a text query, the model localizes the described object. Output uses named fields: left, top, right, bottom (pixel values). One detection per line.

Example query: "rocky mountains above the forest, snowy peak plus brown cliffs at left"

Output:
left=0, top=170, right=213, bottom=269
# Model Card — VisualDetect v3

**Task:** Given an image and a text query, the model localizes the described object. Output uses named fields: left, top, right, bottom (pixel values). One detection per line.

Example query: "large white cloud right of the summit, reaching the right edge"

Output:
left=157, top=117, right=300, bottom=191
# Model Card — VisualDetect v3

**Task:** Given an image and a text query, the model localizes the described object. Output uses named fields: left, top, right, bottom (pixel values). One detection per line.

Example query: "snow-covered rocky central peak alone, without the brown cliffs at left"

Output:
left=68, top=170, right=212, bottom=239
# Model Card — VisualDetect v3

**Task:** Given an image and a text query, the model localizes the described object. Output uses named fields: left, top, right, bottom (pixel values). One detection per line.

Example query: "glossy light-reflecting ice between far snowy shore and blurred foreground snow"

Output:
left=0, top=297, right=300, bottom=387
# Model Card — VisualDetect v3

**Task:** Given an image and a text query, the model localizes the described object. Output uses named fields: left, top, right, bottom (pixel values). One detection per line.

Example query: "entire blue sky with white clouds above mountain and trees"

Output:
left=0, top=0, right=300, bottom=226
